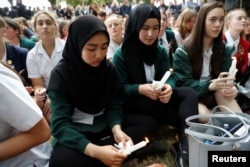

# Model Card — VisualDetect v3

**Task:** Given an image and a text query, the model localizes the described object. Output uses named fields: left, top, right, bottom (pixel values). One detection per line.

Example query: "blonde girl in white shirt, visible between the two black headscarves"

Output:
left=104, top=14, right=124, bottom=62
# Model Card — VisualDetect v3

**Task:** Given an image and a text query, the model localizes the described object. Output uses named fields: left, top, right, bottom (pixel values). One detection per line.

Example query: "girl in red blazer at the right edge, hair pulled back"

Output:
left=223, top=9, right=250, bottom=82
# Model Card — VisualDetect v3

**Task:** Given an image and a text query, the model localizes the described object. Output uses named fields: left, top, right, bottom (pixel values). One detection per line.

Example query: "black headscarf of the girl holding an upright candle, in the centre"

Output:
left=121, top=4, right=161, bottom=82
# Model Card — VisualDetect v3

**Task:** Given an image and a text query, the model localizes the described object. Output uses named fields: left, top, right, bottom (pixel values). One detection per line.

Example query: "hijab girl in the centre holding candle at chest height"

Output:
left=113, top=4, right=198, bottom=166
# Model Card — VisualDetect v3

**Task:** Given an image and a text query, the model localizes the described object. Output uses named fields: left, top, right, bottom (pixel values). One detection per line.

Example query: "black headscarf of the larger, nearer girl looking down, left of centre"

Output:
left=48, top=15, right=117, bottom=114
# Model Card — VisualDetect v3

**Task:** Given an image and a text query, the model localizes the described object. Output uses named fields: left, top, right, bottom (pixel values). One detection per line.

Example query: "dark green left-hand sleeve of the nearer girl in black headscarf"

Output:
left=48, top=91, right=90, bottom=153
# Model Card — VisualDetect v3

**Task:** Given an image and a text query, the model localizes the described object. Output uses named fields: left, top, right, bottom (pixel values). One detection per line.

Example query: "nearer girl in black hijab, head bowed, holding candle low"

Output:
left=48, top=15, right=158, bottom=167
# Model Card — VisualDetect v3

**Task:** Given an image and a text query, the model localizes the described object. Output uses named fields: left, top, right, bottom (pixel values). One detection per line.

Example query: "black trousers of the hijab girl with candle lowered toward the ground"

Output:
left=49, top=114, right=159, bottom=167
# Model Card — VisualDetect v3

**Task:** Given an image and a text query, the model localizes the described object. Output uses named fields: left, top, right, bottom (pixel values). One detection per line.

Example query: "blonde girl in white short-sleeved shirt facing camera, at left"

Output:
left=26, top=11, right=65, bottom=122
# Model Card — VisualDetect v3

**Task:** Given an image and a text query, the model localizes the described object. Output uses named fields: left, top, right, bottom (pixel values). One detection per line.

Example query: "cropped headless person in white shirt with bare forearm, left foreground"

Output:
left=0, top=63, right=52, bottom=167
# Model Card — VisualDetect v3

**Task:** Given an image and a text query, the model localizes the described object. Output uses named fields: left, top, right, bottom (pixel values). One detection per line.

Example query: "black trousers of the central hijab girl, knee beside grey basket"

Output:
left=124, top=87, right=198, bottom=135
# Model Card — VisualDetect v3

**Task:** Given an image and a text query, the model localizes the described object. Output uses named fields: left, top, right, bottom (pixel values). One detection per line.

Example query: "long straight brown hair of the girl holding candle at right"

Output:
left=184, top=1, right=224, bottom=79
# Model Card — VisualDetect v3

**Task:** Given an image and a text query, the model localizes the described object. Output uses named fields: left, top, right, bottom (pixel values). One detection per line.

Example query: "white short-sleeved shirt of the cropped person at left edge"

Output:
left=0, top=64, right=52, bottom=167
